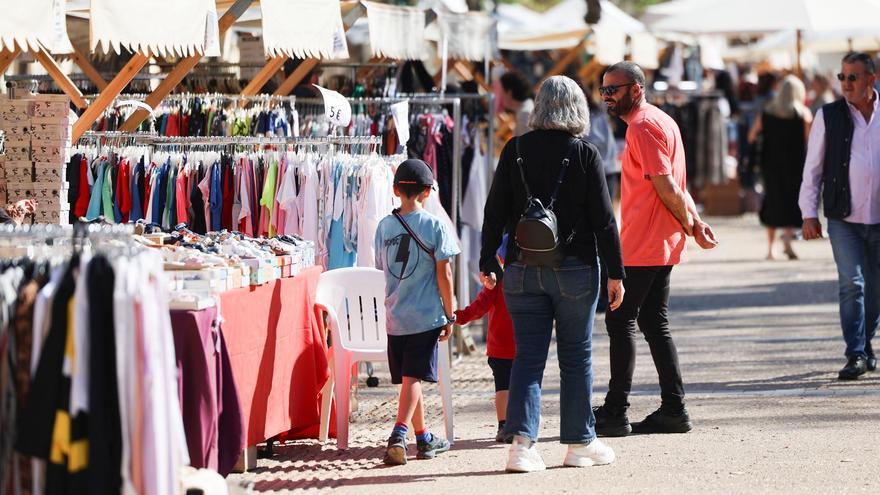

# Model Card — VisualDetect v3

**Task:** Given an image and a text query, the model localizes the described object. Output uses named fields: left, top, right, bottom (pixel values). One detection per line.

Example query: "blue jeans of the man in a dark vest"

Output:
left=828, top=219, right=880, bottom=357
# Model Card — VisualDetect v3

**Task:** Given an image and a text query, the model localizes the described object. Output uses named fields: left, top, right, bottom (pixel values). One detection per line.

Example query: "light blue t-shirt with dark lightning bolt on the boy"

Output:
left=376, top=210, right=461, bottom=335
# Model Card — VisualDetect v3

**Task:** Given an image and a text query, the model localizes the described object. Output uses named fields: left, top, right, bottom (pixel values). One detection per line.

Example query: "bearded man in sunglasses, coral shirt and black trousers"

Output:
left=594, top=62, right=717, bottom=436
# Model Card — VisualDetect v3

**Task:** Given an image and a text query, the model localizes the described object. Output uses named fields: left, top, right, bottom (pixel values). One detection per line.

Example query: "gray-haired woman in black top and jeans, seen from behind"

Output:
left=480, top=76, right=624, bottom=472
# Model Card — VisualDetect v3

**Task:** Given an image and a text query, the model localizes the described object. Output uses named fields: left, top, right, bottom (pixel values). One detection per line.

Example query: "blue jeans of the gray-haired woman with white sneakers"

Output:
left=503, top=257, right=599, bottom=444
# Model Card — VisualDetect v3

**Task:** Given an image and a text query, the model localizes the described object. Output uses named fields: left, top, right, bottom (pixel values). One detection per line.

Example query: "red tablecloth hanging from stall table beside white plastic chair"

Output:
left=220, top=267, right=329, bottom=445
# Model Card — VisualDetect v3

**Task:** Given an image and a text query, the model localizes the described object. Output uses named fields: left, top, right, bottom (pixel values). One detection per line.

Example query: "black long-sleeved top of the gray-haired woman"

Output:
left=480, top=130, right=624, bottom=279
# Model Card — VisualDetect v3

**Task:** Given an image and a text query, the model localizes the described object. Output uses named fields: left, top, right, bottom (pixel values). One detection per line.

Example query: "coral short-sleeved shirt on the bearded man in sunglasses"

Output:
left=620, top=103, right=687, bottom=266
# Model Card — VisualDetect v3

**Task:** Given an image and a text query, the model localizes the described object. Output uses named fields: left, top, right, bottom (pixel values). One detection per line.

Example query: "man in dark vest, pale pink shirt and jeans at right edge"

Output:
left=798, top=53, right=880, bottom=380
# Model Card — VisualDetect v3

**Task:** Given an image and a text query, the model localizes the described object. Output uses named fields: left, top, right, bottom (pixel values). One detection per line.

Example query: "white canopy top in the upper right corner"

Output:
left=651, top=0, right=880, bottom=34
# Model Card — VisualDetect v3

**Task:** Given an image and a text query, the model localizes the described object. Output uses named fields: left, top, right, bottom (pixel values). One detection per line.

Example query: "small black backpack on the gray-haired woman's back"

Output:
left=514, top=138, right=577, bottom=267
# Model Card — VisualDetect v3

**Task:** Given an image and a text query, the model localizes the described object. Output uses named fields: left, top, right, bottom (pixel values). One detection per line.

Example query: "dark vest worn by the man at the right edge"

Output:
left=822, top=98, right=855, bottom=220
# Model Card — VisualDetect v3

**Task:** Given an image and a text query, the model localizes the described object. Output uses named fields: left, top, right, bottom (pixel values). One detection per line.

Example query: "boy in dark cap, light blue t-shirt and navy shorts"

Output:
left=376, top=159, right=460, bottom=465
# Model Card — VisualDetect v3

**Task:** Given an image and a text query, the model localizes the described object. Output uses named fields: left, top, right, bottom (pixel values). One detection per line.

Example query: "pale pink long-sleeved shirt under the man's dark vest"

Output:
left=798, top=91, right=880, bottom=225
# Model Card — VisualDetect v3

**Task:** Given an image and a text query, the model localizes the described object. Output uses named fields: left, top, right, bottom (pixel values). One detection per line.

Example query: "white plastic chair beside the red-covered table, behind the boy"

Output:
left=315, top=268, right=453, bottom=450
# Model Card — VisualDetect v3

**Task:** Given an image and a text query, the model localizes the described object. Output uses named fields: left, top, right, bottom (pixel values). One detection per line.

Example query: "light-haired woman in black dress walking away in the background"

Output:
left=749, top=75, right=813, bottom=260
